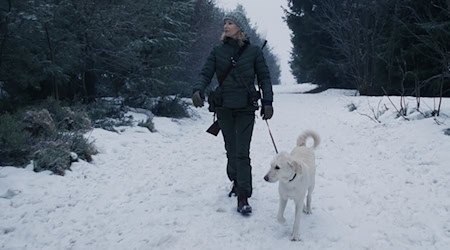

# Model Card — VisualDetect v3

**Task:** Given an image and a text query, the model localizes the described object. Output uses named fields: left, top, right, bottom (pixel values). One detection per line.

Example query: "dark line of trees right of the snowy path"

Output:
left=285, top=0, right=450, bottom=97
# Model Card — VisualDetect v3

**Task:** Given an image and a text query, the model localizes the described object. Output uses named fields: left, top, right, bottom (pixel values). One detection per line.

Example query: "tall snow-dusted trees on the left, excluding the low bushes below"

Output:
left=0, top=0, right=280, bottom=111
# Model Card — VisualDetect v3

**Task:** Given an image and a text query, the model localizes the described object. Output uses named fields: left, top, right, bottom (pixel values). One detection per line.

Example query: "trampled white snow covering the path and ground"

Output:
left=0, top=85, right=450, bottom=250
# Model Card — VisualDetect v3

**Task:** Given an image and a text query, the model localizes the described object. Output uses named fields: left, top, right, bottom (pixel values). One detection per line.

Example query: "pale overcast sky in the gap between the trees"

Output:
left=215, top=0, right=295, bottom=84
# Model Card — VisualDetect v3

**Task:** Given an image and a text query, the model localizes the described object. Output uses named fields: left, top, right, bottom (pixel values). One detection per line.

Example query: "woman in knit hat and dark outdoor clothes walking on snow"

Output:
left=192, top=11, right=273, bottom=214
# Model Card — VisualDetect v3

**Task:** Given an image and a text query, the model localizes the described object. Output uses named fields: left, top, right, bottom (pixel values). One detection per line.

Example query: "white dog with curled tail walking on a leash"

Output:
left=264, top=131, right=320, bottom=241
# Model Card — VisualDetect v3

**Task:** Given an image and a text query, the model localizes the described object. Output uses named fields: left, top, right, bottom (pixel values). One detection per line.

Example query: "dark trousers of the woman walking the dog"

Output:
left=217, top=108, right=255, bottom=197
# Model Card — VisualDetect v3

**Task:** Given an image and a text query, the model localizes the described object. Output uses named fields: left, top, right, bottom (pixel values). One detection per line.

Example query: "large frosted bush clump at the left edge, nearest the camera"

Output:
left=0, top=99, right=97, bottom=175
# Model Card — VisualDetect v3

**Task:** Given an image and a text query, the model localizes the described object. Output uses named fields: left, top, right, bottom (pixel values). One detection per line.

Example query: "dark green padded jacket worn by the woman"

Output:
left=194, top=38, right=273, bottom=108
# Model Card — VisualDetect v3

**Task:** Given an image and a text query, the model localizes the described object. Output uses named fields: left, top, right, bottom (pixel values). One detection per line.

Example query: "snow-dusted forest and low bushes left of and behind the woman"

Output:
left=0, top=0, right=280, bottom=171
